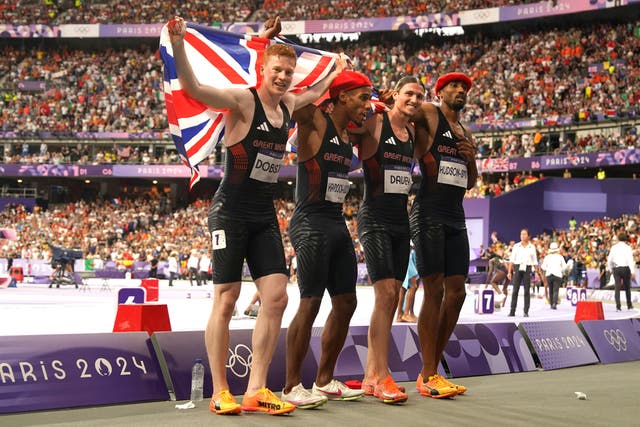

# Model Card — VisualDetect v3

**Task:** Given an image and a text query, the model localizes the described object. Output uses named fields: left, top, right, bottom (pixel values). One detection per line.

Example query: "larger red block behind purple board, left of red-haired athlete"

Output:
left=113, top=304, right=171, bottom=335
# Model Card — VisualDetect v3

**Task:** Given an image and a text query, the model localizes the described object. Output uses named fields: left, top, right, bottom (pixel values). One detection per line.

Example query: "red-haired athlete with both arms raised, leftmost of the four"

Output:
left=167, top=18, right=345, bottom=414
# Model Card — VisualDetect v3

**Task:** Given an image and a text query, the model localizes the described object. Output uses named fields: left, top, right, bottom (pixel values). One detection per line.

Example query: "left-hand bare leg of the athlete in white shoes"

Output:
left=284, top=297, right=328, bottom=393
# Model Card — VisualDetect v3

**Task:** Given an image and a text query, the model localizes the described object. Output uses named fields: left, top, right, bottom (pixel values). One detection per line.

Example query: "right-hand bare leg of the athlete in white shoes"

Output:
left=316, top=293, right=360, bottom=387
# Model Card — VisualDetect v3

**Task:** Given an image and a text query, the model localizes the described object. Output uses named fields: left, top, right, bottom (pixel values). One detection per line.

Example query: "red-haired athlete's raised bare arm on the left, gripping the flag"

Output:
left=168, top=17, right=246, bottom=110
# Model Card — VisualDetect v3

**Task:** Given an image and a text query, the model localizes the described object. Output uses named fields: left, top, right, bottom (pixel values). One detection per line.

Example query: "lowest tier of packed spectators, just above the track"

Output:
left=0, top=194, right=640, bottom=286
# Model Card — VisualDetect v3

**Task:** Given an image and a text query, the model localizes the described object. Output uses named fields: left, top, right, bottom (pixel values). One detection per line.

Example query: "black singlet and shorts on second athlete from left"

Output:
left=289, top=113, right=357, bottom=297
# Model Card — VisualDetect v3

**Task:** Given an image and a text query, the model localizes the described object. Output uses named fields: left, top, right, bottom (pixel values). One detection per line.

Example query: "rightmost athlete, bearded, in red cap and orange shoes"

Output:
left=409, top=73, right=478, bottom=398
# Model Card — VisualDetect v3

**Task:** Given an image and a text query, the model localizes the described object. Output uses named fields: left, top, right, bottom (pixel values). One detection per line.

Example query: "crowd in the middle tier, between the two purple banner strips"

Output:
left=0, top=21, right=640, bottom=149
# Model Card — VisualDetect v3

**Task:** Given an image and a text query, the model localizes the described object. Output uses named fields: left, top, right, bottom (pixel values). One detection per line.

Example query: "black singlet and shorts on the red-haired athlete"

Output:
left=209, top=89, right=290, bottom=283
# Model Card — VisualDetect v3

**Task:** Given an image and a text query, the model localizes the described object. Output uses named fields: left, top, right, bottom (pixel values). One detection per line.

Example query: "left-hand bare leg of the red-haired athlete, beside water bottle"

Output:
left=204, top=282, right=240, bottom=394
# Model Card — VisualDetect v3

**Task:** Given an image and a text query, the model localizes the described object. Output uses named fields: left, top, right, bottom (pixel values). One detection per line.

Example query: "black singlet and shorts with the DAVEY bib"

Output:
left=358, top=113, right=413, bottom=283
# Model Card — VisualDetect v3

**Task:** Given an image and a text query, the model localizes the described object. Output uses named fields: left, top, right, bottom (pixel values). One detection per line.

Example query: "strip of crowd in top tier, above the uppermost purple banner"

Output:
left=0, top=0, right=540, bottom=25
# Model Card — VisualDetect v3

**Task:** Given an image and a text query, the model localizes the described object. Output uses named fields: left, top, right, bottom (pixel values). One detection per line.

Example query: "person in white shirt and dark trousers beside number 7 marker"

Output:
left=507, top=228, right=543, bottom=317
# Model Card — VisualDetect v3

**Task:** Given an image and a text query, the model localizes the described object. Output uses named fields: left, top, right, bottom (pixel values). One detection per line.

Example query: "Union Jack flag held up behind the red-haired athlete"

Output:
left=160, top=22, right=337, bottom=188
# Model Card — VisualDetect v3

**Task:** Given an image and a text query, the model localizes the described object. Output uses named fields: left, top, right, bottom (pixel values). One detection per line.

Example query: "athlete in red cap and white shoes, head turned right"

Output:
left=282, top=70, right=372, bottom=409
